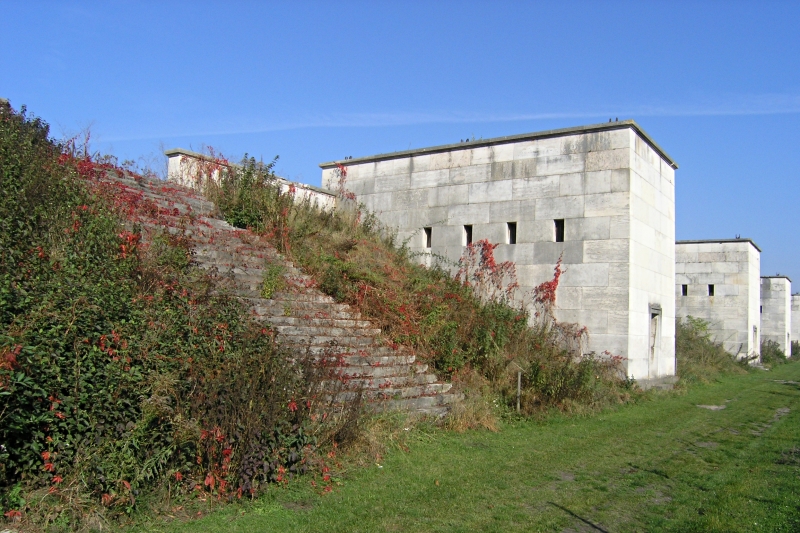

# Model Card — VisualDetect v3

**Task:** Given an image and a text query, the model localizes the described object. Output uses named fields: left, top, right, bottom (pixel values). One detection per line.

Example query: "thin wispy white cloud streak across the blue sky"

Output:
left=106, top=94, right=800, bottom=142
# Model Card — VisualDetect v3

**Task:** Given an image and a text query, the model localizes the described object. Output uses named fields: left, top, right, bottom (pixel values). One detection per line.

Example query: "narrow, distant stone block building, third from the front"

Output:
left=761, top=275, right=792, bottom=357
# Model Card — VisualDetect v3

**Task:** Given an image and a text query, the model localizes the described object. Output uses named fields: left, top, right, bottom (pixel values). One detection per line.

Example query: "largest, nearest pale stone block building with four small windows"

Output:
left=320, top=121, right=677, bottom=384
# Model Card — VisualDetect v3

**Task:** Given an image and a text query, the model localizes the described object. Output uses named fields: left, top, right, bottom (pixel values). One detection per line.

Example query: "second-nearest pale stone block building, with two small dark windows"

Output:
left=675, top=239, right=761, bottom=357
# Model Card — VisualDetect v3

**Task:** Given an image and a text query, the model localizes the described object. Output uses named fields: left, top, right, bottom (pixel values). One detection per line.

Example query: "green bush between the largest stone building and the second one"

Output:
left=675, top=316, right=749, bottom=384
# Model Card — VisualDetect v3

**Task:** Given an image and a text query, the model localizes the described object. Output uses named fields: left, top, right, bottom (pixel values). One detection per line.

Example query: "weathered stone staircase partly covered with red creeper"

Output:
left=90, top=171, right=460, bottom=416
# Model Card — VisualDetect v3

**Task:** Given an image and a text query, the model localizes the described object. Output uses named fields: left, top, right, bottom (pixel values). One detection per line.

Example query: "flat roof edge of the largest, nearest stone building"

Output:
left=319, top=120, right=678, bottom=169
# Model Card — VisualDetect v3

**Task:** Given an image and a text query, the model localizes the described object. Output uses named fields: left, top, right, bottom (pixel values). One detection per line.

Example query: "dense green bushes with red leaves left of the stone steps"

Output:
left=0, top=104, right=346, bottom=531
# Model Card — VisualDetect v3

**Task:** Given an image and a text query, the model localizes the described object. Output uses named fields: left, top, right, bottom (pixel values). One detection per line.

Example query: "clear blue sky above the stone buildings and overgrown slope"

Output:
left=0, top=0, right=800, bottom=282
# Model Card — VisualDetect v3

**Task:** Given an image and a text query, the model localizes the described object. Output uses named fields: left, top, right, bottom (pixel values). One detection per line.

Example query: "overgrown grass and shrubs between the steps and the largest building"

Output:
left=197, top=152, right=632, bottom=414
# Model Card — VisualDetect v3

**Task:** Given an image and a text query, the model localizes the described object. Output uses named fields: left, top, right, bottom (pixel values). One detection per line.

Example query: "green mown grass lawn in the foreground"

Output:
left=137, top=363, right=800, bottom=533
